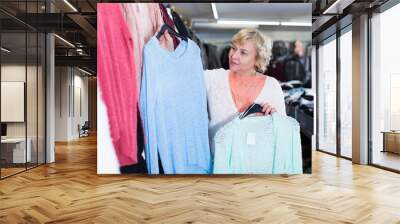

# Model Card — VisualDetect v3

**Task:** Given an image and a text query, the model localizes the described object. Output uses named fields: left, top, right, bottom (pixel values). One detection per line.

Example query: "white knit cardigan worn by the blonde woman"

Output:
left=204, top=69, right=286, bottom=156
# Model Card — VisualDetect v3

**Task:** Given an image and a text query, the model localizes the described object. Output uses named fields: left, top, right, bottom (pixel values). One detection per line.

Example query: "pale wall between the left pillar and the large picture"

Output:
left=55, top=67, right=88, bottom=141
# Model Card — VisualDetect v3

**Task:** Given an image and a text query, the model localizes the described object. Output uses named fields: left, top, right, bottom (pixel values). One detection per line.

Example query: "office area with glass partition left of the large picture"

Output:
left=0, top=0, right=97, bottom=179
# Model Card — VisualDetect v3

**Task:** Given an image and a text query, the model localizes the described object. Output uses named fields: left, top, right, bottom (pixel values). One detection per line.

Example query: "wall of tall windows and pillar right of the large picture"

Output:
left=313, top=1, right=400, bottom=171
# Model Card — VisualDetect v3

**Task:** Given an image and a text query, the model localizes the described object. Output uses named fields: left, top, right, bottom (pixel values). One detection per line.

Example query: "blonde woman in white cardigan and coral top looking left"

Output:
left=205, top=29, right=286, bottom=150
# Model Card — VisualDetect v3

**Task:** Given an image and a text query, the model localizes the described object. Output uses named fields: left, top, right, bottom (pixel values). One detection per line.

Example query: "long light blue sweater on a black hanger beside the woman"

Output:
left=140, top=36, right=211, bottom=174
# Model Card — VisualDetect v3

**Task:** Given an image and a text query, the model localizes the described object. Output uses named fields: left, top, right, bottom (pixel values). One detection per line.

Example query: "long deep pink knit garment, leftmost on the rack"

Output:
left=97, top=3, right=138, bottom=166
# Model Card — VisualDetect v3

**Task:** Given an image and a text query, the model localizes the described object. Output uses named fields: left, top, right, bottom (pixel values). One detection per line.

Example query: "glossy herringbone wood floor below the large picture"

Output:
left=0, top=134, right=400, bottom=224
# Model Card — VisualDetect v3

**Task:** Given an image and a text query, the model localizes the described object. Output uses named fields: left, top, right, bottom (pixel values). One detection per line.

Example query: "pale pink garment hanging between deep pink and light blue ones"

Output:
left=121, top=3, right=170, bottom=93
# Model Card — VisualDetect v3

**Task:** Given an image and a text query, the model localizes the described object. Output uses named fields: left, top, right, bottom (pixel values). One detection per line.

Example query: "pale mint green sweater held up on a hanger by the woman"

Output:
left=213, top=113, right=303, bottom=174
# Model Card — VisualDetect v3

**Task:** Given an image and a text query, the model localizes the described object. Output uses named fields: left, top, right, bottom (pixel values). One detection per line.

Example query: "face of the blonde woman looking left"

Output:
left=229, top=40, right=257, bottom=73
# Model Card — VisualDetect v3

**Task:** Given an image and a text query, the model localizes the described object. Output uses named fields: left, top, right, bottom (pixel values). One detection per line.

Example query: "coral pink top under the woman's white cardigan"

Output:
left=229, top=72, right=267, bottom=112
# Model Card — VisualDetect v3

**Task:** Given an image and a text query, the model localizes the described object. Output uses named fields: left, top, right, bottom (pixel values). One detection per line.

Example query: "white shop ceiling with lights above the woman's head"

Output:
left=170, top=3, right=312, bottom=43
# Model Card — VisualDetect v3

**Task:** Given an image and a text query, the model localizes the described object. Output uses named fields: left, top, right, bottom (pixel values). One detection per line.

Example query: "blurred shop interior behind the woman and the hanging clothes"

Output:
left=97, top=3, right=315, bottom=174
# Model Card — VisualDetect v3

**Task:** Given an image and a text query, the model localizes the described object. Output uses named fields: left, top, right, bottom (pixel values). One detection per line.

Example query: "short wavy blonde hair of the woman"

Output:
left=231, top=28, right=272, bottom=73
